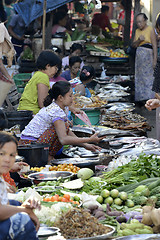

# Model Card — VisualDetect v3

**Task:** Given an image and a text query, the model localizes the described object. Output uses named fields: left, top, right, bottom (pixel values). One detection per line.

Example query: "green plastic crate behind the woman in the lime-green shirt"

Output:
left=13, top=73, right=32, bottom=93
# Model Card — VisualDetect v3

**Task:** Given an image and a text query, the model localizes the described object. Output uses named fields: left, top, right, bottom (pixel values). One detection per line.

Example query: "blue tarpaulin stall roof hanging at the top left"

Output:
left=14, top=0, right=73, bottom=26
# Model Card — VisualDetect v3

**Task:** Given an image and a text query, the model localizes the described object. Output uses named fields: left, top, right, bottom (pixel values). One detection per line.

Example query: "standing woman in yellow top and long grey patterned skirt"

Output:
left=133, top=13, right=157, bottom=106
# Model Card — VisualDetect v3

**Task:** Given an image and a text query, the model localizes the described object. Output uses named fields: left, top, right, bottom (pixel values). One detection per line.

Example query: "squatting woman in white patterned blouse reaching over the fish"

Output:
left=19, top=81, right=101, bottom=160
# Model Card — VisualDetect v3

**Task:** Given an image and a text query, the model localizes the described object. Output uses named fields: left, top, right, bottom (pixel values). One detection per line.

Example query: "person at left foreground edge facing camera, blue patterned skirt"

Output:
left=0, top=132, right=40, bottom=240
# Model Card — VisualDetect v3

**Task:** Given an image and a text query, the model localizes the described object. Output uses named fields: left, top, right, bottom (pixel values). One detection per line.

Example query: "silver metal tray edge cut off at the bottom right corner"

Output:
left=115, top=234, right=160, bottom=240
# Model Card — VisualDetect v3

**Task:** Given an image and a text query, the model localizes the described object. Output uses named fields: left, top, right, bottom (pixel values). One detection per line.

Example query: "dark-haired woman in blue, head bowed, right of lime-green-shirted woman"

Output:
left=61, top=56, right=82, bottom=81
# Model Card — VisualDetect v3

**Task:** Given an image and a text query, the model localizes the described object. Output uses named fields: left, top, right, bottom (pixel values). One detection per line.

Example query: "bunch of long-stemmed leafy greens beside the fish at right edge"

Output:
left=103, top=153, right=160, bottom=192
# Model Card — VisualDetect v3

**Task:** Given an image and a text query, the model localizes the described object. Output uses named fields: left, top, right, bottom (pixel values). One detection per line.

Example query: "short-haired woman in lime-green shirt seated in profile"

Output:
left=18, top=50, right=62, bottom=114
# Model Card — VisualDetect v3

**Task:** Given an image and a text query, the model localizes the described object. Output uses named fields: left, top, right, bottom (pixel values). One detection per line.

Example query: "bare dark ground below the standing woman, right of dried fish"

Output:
left=136, top=107, right=156, bottom=138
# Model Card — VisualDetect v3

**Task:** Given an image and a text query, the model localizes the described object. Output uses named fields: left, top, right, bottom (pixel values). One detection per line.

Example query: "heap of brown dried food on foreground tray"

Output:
left=55, top=208, right=112, bottom=239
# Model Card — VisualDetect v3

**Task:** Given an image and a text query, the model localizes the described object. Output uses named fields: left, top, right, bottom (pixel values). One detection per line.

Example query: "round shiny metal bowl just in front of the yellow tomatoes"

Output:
left=28, top=171, right=74, bottom=184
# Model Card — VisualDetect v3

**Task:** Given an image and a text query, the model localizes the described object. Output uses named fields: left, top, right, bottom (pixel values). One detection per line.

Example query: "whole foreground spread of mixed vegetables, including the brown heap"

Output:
left=16, top=153, right=160, bottom=239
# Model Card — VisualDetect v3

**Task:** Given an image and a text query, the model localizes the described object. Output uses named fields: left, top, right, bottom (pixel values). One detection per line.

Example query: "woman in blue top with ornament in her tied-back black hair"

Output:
left=73, top=66, right=95, bottom=98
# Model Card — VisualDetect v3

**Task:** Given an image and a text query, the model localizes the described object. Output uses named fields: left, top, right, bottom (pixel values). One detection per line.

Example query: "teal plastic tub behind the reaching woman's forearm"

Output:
left=71, top=109, right=100, bottom=125
